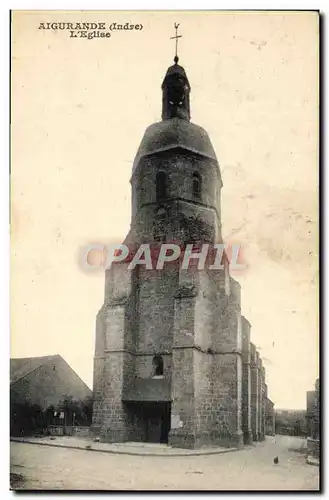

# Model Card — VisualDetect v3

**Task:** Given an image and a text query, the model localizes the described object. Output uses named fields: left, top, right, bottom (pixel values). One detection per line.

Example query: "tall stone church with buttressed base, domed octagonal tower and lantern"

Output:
left=92, top=37, right=267, bottom=448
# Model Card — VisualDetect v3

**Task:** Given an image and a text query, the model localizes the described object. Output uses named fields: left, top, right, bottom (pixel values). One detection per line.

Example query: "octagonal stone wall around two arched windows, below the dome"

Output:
left=132, top=149, right=221, bottom=243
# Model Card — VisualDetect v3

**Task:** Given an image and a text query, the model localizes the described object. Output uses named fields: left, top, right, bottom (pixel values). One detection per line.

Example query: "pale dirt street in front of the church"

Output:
left=11, top=436, right=319, bottom=491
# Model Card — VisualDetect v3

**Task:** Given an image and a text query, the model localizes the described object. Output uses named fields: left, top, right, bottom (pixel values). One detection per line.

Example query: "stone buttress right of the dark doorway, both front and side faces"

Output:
left=170, top=271, right=242, bottom=447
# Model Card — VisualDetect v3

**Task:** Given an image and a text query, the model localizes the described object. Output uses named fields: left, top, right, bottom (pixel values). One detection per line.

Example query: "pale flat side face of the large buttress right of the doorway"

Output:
left=194, top=271, right=242, bottom=447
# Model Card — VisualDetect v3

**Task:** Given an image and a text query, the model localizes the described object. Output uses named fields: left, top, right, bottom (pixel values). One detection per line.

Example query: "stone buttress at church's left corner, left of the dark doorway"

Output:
left=92, top=264, right=134, bottom=442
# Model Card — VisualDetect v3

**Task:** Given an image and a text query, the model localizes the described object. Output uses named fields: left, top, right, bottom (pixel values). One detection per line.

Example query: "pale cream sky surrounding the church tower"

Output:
left=11, top=11, right=319, bottom=409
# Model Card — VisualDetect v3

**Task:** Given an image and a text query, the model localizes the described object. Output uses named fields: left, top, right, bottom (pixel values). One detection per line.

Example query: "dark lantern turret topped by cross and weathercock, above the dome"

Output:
left=161, top=23, right=191, bottom=120
